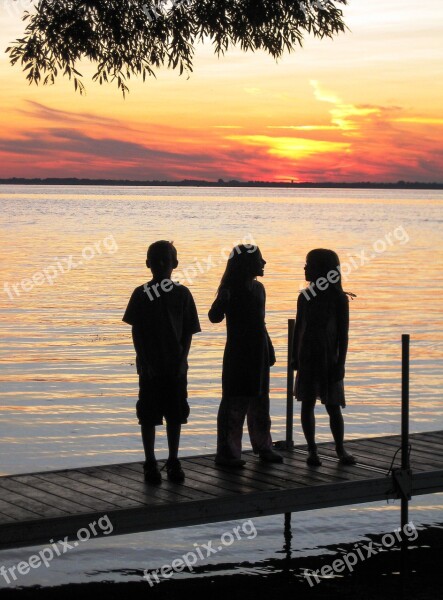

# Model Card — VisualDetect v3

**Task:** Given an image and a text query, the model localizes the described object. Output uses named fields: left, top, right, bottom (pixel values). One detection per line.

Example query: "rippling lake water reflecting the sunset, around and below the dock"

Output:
left=0, top=186, right=443, bottom=587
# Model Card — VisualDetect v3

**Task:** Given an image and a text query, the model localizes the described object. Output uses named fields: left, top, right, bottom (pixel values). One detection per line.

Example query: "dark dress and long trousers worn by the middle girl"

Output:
left=208, top=280, right=275, bottom=458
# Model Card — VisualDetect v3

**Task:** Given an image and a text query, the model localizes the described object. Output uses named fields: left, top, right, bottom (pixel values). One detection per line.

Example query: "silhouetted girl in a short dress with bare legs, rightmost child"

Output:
left=292, top=248, right=355, bottom=465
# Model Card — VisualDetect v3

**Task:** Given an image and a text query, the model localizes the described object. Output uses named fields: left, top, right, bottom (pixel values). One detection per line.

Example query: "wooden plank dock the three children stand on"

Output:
left=0, top=431, right=443, bottom=549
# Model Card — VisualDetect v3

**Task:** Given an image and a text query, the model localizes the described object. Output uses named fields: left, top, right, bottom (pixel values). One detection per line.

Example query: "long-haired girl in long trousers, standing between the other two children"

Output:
left=208, top=245, right=283, bottom=467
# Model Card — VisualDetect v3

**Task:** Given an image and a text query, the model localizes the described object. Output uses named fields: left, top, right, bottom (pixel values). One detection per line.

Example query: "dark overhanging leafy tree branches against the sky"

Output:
left=7, top=0, right=347, bottom=94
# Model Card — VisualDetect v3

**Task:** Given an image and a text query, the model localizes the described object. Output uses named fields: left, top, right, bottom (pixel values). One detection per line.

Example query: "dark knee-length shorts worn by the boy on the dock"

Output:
left=136, top=376, right=189, bottom=426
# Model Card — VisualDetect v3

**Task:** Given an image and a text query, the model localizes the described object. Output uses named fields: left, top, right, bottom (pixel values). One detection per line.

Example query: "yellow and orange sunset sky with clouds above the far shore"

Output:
left=0, top=0, right=443, bottom=182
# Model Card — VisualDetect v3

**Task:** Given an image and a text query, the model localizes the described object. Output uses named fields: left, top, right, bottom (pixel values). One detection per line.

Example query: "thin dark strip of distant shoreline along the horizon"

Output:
left=0, top=177, right=443, bottom=190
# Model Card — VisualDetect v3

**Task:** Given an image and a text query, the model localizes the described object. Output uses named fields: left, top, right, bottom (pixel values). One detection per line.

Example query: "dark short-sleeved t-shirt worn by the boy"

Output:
left=122, top=281, right=201, bottom=377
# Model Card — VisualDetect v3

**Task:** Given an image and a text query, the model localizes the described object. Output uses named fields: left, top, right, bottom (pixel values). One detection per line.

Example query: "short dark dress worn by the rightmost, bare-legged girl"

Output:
left=292, top=286, right=349, bottom=407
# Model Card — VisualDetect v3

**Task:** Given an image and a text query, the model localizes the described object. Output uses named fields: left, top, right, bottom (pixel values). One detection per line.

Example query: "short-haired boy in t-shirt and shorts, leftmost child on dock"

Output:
left=123, top=240, right=201, bottom=484
